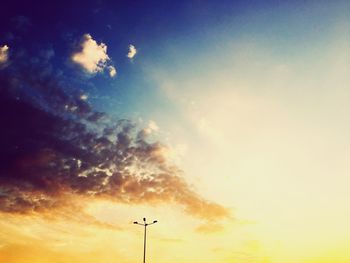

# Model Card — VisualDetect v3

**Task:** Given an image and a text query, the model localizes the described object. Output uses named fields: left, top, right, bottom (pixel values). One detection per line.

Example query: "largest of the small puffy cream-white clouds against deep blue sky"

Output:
left=71, top=34, right=116, bottom=77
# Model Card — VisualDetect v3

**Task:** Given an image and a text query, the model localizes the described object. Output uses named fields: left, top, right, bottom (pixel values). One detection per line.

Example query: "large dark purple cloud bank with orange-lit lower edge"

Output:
left=0, top=48, right=229, bottom=222
